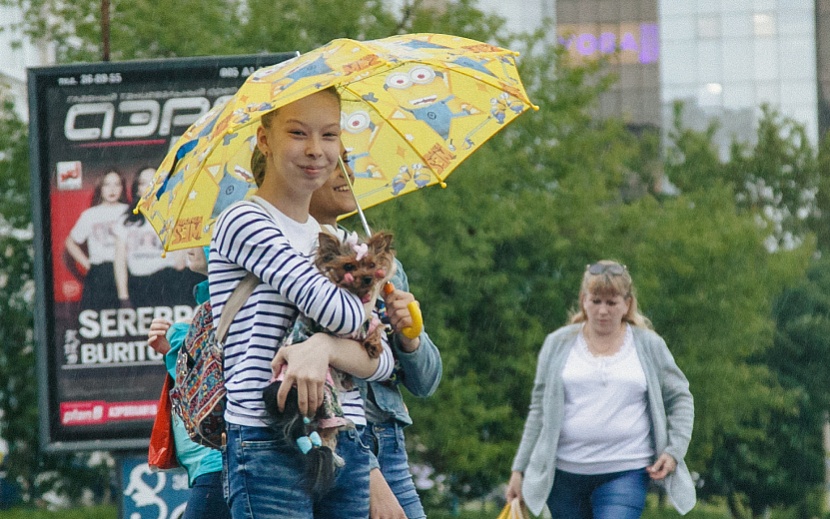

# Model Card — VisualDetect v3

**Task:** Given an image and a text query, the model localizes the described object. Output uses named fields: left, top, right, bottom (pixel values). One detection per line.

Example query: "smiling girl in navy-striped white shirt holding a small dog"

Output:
left=209, top=89, right=392, bottom=519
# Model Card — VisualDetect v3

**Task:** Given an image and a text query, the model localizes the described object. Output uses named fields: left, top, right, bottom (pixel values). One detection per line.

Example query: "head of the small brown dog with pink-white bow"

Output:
left=314, top=231, right=395, bottom=303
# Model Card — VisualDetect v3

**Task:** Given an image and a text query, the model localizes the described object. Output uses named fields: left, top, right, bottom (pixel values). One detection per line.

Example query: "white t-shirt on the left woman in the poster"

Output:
left=69, top=203, right=127, bottom=265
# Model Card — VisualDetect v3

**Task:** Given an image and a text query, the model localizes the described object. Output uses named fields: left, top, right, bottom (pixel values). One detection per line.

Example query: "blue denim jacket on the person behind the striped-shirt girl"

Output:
left=355, top=259, right=443, bottom=426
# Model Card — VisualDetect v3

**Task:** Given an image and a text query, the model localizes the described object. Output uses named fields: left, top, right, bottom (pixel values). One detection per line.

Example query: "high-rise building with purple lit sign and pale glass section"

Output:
left=556, top=0, right=830, bottom=156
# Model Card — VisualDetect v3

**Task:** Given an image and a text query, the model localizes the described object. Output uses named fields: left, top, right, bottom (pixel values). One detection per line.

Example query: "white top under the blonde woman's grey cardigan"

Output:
left=556, top=326, right=654, bottom=474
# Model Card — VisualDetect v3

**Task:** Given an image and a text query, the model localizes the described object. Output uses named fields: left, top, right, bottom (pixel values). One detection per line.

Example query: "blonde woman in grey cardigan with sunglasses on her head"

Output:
left=506, top=260, right=696, bottom=519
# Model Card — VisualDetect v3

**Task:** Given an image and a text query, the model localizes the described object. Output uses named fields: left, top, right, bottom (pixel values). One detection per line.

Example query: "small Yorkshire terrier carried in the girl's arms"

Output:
left=262, top=232, right=395, bottom=497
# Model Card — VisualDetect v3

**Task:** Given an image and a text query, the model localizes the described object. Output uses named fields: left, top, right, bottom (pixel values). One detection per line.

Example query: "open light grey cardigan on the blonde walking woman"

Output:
left=512, top=324, right=697, bottom=515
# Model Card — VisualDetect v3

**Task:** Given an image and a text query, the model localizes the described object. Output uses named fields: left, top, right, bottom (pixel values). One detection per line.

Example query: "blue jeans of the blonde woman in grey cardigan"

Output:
left=548, top=468, right=649, bottom=519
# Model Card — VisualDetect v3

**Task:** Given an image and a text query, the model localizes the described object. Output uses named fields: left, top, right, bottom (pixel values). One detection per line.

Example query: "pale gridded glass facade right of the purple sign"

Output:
left=659, top=0, right=819, bottom=153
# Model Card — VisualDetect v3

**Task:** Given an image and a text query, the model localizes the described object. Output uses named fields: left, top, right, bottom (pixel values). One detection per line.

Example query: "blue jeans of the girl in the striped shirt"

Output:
left=222, top=424, right=369, bottom=519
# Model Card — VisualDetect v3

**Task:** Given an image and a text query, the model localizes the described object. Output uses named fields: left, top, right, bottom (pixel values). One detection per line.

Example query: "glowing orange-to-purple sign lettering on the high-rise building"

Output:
left=558, top=23, right=660, bottom=64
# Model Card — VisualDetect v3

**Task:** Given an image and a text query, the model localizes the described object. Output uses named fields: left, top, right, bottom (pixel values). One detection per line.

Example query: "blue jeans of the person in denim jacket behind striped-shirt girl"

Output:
left=360, top=422, right=426, bottom=519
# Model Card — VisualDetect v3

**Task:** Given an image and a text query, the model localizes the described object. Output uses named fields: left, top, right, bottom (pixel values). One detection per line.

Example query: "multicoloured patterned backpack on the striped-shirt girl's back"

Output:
left=170, top=272, right=259, bottom=449
